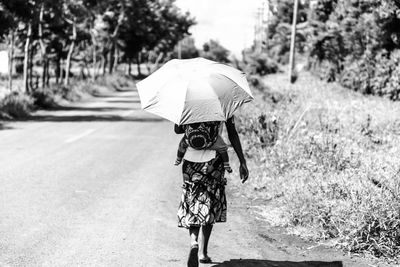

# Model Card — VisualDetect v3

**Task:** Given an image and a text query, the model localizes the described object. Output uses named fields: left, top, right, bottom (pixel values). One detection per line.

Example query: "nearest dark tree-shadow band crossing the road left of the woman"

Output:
left=24, top=115, right=164, bottom=122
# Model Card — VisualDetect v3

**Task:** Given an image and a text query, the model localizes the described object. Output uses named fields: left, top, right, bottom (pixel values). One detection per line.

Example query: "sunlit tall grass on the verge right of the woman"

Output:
left=237, top=73, right=400, bottom=263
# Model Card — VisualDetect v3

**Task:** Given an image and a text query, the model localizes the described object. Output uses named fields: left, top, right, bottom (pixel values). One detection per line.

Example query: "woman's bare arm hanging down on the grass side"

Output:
left=225, top=117, right=249, bottom=183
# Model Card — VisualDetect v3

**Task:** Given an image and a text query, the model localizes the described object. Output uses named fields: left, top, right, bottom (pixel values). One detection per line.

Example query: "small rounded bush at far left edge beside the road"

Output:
left=0, top=92, right=34, bottom=119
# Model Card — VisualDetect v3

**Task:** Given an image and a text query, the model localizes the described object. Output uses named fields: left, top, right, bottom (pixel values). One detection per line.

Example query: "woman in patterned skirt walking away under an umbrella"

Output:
left=175, top=117, right=249, bottom=267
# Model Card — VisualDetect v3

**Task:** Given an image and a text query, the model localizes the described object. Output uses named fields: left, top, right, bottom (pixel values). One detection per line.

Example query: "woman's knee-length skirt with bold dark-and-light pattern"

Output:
left=178, top=155, right=226, bottom=228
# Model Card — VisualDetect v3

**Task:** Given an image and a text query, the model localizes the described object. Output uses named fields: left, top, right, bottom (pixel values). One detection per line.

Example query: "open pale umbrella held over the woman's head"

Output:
left=137, top=58, right=253, bottom=125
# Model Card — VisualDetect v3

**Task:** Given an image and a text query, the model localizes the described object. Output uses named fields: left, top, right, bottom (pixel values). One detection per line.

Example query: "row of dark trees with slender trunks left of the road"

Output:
left=0, top=0, right=194, bottom=93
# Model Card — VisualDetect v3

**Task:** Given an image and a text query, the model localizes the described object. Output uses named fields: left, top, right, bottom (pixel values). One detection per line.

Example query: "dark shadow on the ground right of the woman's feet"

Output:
left=214, top=259, right=343, bottom=267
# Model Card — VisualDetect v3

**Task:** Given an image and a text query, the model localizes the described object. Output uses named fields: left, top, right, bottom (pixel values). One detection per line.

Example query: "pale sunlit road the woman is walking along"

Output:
left=0, top=91, right=370, bottom=266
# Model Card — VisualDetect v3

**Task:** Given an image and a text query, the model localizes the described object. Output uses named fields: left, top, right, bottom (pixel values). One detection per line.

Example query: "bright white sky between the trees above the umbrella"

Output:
left=176, top=0, right=261, bottom=57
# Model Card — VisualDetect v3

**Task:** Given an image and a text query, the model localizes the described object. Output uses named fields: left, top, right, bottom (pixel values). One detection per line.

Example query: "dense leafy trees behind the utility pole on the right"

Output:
left=252, top=0, right=400, bottom=100
